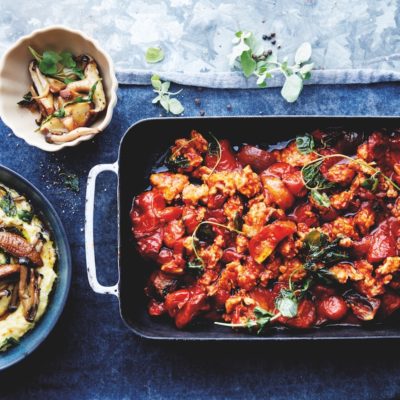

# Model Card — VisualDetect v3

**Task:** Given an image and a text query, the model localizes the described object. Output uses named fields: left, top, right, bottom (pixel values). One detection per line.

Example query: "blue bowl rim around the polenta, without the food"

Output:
left=0, top=165, right=72, bottom=371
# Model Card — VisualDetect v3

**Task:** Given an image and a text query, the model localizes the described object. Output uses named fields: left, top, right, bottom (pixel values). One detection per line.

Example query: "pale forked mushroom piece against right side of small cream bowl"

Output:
left=67, top=57, right=107, bottom=114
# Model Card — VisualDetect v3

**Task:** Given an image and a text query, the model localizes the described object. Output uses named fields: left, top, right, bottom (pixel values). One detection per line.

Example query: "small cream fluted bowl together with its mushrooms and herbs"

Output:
left=0, top=26, right=118, bottom=151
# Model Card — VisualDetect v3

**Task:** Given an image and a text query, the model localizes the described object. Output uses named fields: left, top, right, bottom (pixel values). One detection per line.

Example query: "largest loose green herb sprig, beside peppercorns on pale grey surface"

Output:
left=229, top=31, right=314, bottom=103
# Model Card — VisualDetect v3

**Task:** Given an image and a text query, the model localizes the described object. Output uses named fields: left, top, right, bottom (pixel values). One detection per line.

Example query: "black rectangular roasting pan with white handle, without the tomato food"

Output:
left=85, top=116, right=400, bottom=341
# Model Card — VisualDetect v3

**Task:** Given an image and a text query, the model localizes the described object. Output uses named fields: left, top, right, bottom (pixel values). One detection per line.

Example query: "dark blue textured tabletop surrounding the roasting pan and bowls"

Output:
left=0, top=84, right=400, bottom=400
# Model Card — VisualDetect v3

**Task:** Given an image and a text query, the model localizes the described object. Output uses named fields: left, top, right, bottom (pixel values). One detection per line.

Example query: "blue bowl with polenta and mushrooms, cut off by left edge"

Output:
left=0, top=166, right=71, bottom=370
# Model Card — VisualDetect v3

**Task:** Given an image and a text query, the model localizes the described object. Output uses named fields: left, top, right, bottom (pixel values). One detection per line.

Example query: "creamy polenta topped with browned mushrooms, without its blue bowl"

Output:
left=0, top=184, right=57, bottom=351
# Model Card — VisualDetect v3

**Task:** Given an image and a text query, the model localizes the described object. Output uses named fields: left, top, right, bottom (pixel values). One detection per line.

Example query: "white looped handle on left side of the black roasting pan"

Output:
left=85, top=162, right=119, bottom=297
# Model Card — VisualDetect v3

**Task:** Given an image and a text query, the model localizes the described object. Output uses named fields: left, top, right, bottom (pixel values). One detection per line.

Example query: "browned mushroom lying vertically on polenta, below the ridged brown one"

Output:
left=18, top=265, right=41, bottom=322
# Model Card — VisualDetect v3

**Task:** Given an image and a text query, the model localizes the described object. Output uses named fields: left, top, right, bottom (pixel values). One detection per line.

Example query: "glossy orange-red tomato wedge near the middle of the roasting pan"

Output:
left=249, top=221, right=296, bottom=264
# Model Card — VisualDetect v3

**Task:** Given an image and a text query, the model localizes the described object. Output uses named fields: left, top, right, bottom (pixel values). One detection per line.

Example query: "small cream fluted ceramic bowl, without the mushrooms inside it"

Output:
left=0, top=26, right=118, bottom=151
